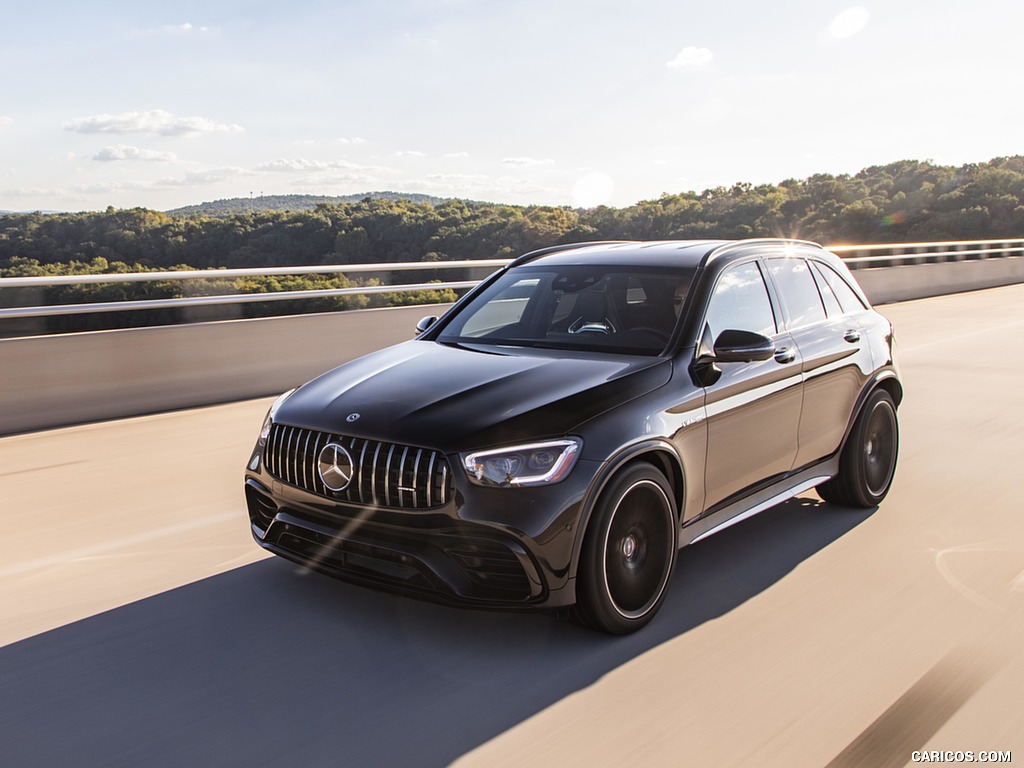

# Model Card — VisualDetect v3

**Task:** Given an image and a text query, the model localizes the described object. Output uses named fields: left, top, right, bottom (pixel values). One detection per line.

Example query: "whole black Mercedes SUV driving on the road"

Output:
left=246, top=240, right=903, bottom=633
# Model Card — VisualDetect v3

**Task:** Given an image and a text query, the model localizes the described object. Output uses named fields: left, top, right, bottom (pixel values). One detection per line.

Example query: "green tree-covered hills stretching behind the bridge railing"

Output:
left=0, top=156, right=1024, bottom=275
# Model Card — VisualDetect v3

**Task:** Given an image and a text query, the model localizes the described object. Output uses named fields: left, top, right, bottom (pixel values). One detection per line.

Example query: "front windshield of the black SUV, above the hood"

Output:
left=437, top=264, right=693, bottom=354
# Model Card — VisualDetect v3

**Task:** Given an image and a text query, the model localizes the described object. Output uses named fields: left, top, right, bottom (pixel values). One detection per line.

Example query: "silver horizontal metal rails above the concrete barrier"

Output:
left=0, top=239, right=1024, bottom=319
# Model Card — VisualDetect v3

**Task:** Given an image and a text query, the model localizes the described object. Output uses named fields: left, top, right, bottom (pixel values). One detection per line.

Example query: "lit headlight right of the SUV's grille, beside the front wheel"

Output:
left=462, top=437, right=583, bottom=485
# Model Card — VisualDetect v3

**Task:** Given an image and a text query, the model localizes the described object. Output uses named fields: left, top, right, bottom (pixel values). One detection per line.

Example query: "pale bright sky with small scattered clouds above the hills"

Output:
left=0, top=0, right=1024, bottom=211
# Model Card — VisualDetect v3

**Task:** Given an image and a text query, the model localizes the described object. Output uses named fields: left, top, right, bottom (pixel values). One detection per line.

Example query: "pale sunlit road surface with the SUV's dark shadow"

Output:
left=0, top=286, right=1024, bottom=768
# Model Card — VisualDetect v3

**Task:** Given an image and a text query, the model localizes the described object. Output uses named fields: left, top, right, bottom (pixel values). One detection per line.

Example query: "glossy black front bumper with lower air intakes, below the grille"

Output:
left=245, top=448, right=588, bottom=608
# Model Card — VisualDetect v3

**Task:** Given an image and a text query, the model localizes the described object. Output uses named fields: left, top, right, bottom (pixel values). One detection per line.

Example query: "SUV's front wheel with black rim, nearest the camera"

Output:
left=574, top=464, right=678, bottom=635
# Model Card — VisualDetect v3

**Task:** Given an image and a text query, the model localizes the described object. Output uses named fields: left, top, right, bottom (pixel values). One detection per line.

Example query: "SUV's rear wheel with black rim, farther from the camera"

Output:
left=817, top=389, right=899, bottom=509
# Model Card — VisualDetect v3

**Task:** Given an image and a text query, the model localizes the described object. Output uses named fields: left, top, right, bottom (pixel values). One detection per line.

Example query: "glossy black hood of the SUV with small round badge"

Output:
left=275, top=340, right=672, bottom=453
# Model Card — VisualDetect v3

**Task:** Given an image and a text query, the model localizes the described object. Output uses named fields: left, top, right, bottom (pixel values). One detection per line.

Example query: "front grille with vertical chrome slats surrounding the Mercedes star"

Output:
left=263, top=424, right=453, bottom=509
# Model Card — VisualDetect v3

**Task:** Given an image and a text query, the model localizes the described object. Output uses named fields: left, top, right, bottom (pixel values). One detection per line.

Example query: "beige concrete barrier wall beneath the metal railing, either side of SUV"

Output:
left=0, top=257, right=1024, bottom=434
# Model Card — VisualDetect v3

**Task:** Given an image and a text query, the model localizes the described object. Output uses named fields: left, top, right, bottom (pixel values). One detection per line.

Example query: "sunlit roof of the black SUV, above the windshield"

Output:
left=513, top=239, right=821, bottom=268
